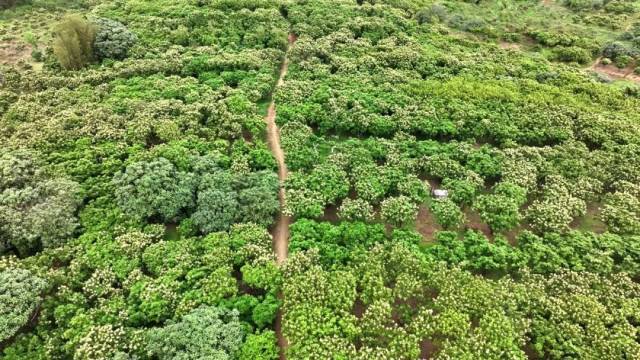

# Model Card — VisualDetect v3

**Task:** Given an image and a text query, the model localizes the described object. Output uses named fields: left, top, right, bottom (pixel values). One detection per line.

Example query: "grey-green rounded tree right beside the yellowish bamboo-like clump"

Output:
left=93, top=18, right=138, bottom=60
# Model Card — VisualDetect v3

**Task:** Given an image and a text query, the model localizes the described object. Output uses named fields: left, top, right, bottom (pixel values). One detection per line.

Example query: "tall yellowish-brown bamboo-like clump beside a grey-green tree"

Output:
left=53, top=15, right=96, bottom=70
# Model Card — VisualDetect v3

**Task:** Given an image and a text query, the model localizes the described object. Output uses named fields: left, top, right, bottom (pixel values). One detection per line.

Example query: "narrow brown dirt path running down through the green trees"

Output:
left=264, top=34, right=297, bottom=360
